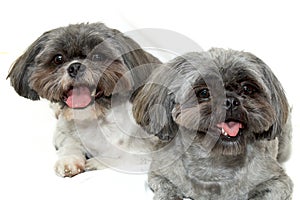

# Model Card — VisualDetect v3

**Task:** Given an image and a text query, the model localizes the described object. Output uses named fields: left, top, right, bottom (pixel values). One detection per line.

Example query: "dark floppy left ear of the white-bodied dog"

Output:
left=7, top=32, right=49, bottom=100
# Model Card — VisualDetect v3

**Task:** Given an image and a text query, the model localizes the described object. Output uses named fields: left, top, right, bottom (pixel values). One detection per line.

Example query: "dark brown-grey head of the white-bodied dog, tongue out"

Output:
left=8, top=23, right=159, bottom=112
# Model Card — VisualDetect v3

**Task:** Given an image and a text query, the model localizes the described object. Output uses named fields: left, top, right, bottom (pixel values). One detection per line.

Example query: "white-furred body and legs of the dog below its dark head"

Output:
left=54, top=101, right=157, bottom=177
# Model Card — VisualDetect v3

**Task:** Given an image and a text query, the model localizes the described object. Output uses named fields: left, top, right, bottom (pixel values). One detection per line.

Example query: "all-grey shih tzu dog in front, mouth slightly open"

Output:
left=133, top=49, right=293, bottom=200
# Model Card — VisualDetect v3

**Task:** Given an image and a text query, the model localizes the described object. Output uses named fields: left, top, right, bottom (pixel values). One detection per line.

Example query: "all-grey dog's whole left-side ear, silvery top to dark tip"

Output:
left=132, top=57, right=193, bottom=141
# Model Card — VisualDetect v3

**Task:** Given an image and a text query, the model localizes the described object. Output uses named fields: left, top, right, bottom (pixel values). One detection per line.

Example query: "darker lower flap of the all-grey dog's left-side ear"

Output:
left=132, top=83, right=178, bottom=141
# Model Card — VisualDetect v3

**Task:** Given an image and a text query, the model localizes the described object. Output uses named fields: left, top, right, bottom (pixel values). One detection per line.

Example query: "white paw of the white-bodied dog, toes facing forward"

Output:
left=55, top=155, right=85, bottom=177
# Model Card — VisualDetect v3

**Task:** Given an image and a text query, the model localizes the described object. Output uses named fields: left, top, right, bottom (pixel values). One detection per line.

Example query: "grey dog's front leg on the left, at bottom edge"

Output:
left=148, top=172, right=183, bottom=200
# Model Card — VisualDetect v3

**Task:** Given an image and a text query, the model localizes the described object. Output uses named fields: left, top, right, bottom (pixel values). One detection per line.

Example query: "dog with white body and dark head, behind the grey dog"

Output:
left=8, top=23, right=160, bottom=177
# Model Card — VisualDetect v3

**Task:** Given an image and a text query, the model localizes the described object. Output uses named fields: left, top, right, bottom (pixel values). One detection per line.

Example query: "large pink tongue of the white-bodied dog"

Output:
left=66, top=87, right=92, bottom=108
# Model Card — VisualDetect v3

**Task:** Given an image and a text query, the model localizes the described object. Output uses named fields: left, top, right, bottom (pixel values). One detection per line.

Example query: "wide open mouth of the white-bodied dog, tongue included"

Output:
left=63, top=85, right=103, bottom=109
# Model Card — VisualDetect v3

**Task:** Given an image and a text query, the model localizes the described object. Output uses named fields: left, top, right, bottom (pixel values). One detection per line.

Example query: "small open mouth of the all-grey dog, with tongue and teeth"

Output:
left=217, top=121, right=244, bottom=139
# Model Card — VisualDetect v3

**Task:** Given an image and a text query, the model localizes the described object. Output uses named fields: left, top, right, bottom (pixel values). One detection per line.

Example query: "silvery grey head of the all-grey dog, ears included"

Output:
left=133, top=49, right=289, bottom=155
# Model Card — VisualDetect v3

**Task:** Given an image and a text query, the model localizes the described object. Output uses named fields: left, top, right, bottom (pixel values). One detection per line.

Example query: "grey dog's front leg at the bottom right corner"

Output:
left=248, top=172, right=293, bottom=200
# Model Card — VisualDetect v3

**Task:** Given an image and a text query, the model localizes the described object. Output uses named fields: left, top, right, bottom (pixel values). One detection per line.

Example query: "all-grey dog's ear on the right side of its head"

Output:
left=249, top=54, right=290, bottom=140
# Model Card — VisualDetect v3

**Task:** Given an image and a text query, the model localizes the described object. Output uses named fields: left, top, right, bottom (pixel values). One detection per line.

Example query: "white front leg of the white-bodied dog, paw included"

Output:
left=54, top=119, right=86, bottom=177
